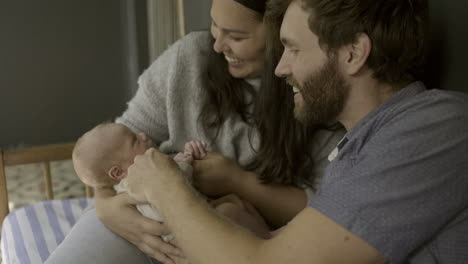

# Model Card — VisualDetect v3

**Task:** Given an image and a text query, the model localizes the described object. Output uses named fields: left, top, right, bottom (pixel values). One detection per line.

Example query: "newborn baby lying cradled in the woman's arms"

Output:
left=72, top=123, right=270, bottom=241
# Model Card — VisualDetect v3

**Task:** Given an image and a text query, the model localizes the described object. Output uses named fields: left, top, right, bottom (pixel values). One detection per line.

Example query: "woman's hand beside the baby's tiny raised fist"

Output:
left=193, top=152, right=244, bottom=196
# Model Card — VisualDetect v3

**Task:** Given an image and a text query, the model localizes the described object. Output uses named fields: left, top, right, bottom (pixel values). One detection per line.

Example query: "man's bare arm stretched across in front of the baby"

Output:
left=147, top=176, right=384, bottom=264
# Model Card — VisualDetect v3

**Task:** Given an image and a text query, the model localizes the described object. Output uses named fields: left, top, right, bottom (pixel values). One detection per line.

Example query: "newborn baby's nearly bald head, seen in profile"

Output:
left=73, top=123, right=152, bottom=187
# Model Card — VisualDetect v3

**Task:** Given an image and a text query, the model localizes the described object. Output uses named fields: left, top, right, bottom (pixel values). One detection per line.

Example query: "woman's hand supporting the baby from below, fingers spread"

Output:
left=95, top=190, right=182, bottom=264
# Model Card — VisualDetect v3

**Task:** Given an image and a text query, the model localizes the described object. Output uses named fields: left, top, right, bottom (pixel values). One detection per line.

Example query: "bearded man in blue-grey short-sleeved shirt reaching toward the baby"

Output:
left=121, top=0, right=468, bottom=264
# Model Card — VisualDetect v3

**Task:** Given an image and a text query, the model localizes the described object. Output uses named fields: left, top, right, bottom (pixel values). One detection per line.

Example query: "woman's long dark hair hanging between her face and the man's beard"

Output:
left=250, top=1, right=317, bottom=187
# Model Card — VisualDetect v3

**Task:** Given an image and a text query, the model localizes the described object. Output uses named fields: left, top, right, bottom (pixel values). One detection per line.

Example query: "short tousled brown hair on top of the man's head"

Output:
left=301, top=0, right=429, bottom=84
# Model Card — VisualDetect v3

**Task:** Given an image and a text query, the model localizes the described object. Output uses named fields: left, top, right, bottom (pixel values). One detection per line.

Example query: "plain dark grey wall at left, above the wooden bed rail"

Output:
left=0, top=0, right=146, bottom=148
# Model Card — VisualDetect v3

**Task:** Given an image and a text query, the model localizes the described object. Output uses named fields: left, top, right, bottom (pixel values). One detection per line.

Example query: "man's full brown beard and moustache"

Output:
left=288, top=57, right=349, bottom=126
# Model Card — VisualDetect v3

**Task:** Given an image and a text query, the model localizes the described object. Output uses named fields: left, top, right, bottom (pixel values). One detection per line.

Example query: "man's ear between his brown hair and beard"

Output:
left=343, top=33, right=372, bottom=76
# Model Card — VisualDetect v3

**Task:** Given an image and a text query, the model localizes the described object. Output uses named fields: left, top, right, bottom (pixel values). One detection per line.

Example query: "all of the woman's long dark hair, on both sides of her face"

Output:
left=200, top=0, right=322, bottom=186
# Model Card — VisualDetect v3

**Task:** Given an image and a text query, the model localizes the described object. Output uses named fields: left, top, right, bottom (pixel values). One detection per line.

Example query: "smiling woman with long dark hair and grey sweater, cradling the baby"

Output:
left=47, top=0, right=341, bottom=263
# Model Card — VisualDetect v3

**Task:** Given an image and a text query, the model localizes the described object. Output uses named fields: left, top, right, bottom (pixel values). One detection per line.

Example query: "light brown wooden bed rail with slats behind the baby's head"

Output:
left=0, top=143, right=92, bottom=229
